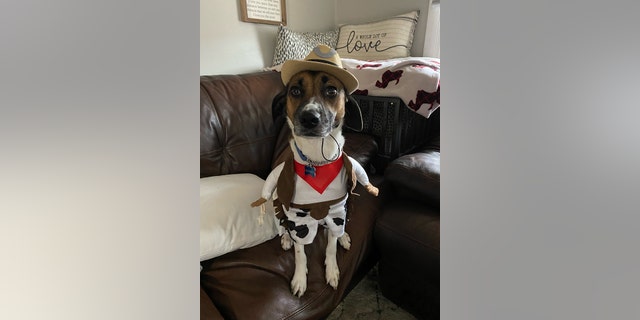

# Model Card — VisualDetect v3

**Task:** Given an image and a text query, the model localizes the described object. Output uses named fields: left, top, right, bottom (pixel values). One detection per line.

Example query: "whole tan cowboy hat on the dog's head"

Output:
left=280, top=44, right=358, bottom=94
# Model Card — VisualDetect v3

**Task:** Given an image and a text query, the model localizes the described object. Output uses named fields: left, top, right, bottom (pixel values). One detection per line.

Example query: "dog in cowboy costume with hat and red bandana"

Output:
left=251, top=45, right=378, bottom=297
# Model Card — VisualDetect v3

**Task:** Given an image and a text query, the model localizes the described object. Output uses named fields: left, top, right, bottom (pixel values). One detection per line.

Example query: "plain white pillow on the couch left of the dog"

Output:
left=200, top=173, right=278, bottom=261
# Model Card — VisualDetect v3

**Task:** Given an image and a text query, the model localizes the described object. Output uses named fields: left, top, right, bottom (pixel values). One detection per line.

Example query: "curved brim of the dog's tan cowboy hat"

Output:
left=280, top=60, right=358, bottom=94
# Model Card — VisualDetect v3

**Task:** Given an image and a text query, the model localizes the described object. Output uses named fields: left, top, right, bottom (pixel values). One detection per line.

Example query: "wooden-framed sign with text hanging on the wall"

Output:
left=240, top=0, right=287, bottom=26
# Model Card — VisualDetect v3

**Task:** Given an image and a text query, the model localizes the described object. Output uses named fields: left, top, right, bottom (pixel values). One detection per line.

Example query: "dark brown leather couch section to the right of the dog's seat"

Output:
left=374, top=110, right=440, bottom=319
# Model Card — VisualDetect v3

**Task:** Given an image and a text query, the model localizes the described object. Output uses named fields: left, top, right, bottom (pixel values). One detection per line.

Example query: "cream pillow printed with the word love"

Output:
left=336, top=11, right=420, bottom=60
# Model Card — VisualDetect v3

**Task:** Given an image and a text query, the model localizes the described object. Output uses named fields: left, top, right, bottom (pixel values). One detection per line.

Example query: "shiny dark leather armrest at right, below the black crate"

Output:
left=384, top=149, right=440, bottom=208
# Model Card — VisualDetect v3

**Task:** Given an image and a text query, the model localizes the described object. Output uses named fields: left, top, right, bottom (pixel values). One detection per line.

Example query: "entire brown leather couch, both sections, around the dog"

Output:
left=200, top=72, right=440, bottom=320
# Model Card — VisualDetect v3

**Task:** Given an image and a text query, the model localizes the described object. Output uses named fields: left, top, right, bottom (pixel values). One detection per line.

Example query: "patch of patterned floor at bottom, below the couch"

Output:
left=327, top=266, right=416, bottom=320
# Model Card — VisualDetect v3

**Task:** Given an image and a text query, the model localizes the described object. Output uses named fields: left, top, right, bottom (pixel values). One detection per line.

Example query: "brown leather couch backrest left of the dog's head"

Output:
left=200, top=72, right=284, bottom=178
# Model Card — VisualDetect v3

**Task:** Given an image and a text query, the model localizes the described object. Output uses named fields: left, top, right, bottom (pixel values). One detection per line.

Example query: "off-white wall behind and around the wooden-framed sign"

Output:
left=200, top=0, right=335, bottom=75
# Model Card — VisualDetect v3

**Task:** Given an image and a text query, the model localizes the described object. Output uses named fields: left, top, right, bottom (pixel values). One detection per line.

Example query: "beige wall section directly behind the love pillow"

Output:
left=332, top=0, right=431, bottom=57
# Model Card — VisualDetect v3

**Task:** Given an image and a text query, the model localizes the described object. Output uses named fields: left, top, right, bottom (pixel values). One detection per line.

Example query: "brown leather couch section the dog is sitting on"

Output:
left=200, top=72, right=382, bottom=320
